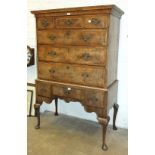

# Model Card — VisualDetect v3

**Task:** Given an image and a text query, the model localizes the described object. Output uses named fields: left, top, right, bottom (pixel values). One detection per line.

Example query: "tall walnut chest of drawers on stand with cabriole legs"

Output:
left=32, top=5, right=123, bottom=150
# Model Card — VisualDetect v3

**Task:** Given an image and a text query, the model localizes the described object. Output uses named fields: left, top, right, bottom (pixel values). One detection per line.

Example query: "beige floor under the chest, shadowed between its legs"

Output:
left=27, top=112, right=128, bottom=155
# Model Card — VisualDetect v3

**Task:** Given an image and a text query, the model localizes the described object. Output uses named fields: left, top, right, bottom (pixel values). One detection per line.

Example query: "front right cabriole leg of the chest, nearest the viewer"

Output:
left=98, top=116, right=110, bottom=151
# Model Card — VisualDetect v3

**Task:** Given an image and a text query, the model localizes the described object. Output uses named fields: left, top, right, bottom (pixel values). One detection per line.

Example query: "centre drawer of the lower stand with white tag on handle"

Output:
left=52, top=86, right=84, bottom=100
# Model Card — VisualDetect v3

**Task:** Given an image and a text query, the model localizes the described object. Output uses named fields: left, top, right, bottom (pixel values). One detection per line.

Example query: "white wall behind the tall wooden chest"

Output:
left=27, top=0, right=128, bottom=128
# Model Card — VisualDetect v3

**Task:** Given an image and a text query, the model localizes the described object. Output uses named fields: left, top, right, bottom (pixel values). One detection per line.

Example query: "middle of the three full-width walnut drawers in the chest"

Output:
left=38, top=45, right=106, bottom=66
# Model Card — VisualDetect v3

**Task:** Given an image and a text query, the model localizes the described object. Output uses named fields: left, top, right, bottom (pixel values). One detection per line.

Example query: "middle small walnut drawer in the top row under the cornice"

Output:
left=56, top=16, right=83, bottom=28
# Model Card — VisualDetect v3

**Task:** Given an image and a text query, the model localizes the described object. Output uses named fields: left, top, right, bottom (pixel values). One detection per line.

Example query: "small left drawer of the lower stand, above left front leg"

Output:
left=37, top=82, right=52, bottom=97
